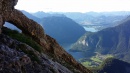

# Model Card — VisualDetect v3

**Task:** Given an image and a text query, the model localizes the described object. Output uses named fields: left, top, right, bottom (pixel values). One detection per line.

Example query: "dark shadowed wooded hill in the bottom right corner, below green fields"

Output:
left=95, top=58, right=130, bottom=73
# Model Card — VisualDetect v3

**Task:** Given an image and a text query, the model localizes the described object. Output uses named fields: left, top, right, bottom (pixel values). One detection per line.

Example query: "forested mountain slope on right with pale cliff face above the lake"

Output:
left=71, top=17, right=130, bottom=62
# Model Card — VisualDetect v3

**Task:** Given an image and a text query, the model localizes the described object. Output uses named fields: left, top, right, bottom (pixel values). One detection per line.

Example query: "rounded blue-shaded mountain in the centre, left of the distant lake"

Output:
left=42, top=16, right=85, bottom=44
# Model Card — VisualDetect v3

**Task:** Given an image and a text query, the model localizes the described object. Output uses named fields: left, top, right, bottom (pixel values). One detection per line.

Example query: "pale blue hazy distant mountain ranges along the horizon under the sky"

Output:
left=32, top=11, right=130, bottom=30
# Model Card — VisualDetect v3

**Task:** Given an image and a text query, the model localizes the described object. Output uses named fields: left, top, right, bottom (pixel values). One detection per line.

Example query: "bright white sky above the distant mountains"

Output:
left=15, top=0, right=130, bottom=13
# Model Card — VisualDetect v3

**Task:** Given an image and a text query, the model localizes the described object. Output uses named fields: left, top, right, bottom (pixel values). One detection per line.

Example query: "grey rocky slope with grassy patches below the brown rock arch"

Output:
left=0, top=34, right=72, bottom=73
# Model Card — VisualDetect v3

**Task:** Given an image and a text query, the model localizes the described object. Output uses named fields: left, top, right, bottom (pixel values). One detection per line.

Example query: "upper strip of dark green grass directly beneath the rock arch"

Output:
left=2, top=27, right=43, bottom=52
